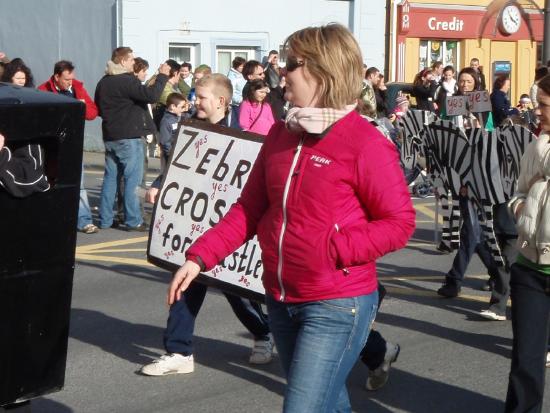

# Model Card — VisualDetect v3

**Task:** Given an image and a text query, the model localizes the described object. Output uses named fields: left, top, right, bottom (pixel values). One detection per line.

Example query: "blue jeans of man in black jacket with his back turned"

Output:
left=99, top=138, right=144, bottom=228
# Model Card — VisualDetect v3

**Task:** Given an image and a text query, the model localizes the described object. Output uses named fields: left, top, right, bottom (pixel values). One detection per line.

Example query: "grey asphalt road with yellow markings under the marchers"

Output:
left=32, top=154, right=550, bottom=413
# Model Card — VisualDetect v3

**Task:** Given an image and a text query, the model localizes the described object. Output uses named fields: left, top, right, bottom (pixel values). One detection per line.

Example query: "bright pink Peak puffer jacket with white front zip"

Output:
left=186, top=112, right=415, bottom=303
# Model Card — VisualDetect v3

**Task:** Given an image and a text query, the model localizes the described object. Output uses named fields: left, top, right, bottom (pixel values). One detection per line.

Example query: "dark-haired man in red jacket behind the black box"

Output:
left=38, top=60, right=99, bottom=234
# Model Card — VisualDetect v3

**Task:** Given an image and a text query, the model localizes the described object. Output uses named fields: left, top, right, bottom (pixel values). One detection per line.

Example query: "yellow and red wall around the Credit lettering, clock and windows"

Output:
left=390, top=0, right=543, bottom=104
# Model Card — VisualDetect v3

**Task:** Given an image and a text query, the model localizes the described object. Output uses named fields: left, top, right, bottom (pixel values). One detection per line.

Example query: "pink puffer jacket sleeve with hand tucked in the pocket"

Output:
left=332, top=134, right=416, bottom=266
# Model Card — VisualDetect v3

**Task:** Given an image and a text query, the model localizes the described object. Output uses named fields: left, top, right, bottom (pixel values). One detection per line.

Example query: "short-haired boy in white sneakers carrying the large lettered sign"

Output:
left=141, top=73, right=273, bottom=376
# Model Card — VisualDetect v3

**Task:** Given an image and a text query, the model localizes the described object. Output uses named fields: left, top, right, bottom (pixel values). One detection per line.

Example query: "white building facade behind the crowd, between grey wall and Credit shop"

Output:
left=121, top=0, right=386, bottom=71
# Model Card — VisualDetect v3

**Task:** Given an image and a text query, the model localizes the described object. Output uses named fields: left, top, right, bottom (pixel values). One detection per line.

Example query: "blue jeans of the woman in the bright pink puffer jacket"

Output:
left=266, top=291, right=378, bottom=413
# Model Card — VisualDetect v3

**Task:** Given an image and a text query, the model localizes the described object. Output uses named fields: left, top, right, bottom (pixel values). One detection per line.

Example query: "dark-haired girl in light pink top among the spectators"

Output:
left=239, top=79, right=275, bottom=135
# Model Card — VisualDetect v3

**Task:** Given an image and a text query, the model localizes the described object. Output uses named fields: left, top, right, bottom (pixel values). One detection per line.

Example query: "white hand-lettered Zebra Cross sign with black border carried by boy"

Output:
left=147, top=121, right=264, bottom=299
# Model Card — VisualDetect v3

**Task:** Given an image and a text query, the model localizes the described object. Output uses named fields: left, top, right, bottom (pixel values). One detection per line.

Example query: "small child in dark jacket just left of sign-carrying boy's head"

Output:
left=159, top=93, right=189, bottom=170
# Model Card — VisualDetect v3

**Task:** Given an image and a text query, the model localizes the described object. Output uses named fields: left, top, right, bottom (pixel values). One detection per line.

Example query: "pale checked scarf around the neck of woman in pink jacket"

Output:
left=285, top=104, right=357, bottom=134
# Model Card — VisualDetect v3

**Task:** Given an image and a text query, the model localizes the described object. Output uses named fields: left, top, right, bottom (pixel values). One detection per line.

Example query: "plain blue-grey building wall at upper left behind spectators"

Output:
left=0, top=0, right=116, bottom=150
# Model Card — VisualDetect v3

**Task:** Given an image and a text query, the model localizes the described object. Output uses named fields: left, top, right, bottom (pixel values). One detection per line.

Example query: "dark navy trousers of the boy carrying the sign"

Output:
left=164, top=282, right=269, bottom=356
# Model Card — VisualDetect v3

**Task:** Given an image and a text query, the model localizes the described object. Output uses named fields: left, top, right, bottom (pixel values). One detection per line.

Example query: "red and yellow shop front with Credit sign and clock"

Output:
left=390, top=0, right=543, bottom=103
